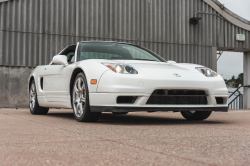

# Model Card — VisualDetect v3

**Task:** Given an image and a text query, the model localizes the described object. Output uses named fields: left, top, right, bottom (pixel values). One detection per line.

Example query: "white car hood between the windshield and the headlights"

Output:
left=94, top=60, right=203, bottom=73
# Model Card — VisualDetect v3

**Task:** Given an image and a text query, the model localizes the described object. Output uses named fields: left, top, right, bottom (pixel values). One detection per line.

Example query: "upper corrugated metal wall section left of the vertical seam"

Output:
left=1, top=0, right=76, bottom=35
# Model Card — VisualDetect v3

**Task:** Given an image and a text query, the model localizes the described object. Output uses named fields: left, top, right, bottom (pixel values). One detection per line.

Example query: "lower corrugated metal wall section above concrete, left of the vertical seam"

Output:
left=1, top=32, right=76, bottom=67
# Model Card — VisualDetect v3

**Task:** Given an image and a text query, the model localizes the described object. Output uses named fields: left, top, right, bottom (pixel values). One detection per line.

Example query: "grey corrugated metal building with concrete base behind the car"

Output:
left=0, top=0, right=250, bottom=108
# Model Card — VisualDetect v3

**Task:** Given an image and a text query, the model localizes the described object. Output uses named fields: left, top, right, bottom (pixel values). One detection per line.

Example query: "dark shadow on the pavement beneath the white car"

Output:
left=47, top=113, right=229, bottom=125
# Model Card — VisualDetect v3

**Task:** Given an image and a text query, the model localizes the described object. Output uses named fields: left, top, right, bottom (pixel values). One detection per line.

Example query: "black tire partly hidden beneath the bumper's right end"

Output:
left=181, top=111, right=212, bottom=120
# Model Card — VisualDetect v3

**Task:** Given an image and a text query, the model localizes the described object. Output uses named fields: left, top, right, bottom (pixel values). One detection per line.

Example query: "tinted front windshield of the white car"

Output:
left=77, top=42, right=166, bottom=62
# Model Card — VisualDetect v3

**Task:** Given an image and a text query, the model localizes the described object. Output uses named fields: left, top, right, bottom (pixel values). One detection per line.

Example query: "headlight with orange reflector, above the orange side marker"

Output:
left=102, top=63, right=138, bottom=74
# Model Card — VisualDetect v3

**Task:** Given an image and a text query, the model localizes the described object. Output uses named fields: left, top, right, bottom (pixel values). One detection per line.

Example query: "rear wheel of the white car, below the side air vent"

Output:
left=29, top=81, right=49, bottom=115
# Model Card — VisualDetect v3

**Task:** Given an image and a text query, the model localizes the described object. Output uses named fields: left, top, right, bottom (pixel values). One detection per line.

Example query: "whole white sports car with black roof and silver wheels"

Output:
left=28, top=41, right=228, bottom=122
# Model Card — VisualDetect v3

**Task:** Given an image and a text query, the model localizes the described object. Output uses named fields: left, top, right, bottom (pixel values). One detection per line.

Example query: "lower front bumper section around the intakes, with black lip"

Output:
left=89, top=93, right=228, bottom=112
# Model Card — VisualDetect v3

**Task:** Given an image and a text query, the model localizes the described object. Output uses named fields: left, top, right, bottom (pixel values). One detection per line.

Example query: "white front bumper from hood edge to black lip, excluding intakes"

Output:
left=89, top=70, right=228, bottom=112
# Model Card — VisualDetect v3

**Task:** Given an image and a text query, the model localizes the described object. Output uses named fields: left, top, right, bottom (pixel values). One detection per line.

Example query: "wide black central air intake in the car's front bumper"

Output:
left=147, top=90, right=207, bottom=105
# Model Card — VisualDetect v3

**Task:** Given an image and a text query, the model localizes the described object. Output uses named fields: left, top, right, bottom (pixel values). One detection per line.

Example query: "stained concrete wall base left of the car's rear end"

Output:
left=0, top=67, right=33, bottom=108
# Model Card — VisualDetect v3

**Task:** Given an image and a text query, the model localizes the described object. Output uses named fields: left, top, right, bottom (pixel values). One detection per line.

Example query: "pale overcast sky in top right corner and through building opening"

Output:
left=217, top=0, right=250, bottom=79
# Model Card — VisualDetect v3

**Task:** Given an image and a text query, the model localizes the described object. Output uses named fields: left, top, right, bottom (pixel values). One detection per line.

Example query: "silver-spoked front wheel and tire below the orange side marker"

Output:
left=71, top=73, right=101, bottom=122
